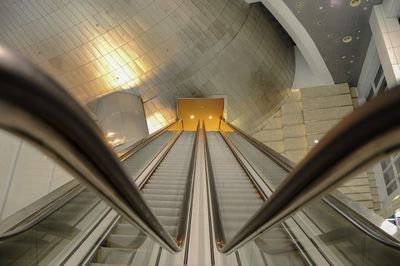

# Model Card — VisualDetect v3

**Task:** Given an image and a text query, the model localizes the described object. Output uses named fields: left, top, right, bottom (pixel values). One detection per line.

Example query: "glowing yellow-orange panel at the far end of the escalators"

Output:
left=177, top=98, right=224, bottom=131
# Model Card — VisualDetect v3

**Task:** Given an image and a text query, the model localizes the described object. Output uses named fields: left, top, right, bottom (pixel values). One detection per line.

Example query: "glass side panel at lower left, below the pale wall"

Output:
left=0, top=190, right=109, bottom=265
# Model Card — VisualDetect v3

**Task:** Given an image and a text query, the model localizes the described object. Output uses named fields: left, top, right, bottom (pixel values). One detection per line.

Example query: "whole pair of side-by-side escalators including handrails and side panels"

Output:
left=0, top=45, right=400, bottom=265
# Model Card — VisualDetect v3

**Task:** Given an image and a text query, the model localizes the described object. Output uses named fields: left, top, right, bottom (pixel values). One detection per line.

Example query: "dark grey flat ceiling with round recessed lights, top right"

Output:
left=283, top=0, right=382, bottom=86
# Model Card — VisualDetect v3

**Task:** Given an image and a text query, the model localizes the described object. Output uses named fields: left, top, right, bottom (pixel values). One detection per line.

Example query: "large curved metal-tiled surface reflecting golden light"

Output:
left=0, top=0, right=294, bottom=129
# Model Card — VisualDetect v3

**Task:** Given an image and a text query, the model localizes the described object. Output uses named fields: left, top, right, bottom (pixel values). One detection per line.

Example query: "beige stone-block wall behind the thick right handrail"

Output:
left=252, top=84, right=374, bottom=208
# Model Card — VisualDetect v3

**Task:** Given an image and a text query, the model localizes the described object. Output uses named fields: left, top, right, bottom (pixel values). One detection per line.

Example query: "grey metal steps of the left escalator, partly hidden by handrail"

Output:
left=90, top=132, right=196, bottom=265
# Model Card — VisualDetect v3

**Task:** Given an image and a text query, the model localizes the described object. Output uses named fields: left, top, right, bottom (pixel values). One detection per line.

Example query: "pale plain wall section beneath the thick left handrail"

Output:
left=0, top=131, right=72, bottom=220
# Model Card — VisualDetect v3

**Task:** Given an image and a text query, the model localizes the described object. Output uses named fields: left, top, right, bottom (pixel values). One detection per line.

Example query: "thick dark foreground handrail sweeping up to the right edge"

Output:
left=217, top=87, right=400, bottom=253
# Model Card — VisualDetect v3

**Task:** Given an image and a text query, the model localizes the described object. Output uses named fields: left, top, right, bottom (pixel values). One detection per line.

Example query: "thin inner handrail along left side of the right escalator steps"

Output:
left=203, top=121, right=226, bottom=249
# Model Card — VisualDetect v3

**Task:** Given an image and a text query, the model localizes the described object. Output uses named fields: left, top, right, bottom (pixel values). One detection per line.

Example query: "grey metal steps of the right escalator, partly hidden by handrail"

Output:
left=206, top=132, right=306, bottom=265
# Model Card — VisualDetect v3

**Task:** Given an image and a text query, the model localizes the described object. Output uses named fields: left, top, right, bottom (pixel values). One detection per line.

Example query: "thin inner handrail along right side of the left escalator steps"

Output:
left=176, top=121, right=200, bottom=247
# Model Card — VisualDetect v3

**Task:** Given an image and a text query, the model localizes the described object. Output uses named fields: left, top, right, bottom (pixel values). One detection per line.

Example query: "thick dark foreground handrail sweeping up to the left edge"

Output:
left=0, top=46, right=181, bottom=252
